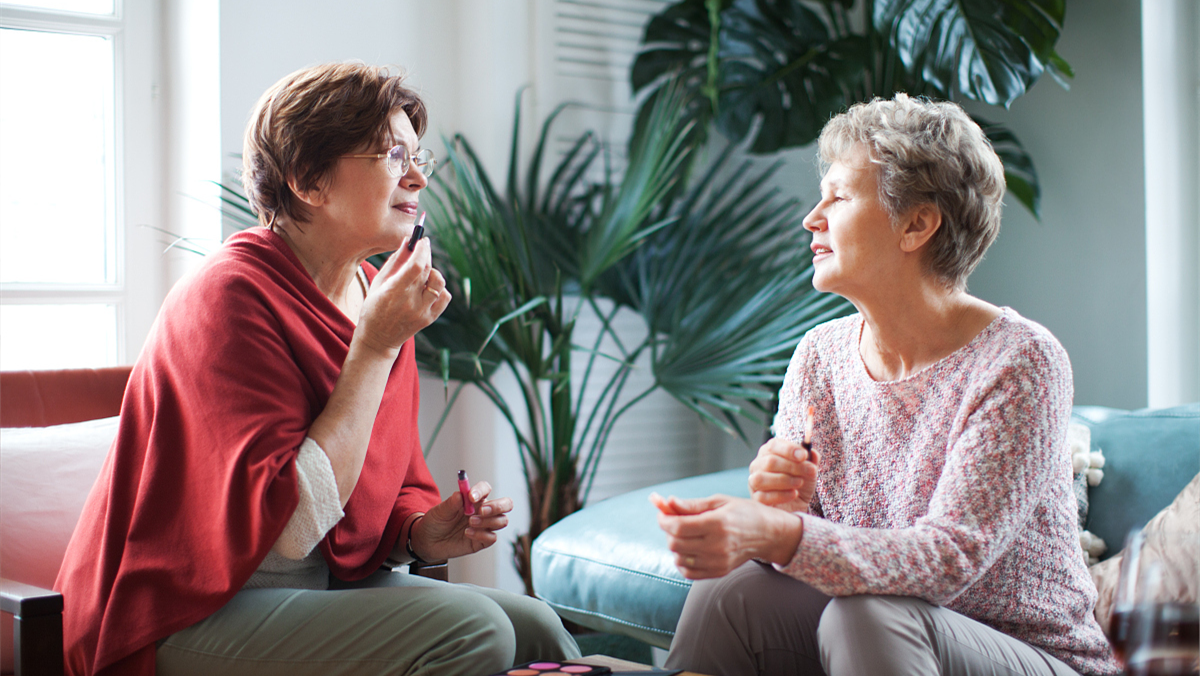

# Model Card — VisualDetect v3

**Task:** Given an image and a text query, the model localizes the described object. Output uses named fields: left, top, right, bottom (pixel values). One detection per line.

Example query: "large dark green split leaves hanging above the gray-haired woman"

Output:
left=630, top=0, right=1073, bottom=216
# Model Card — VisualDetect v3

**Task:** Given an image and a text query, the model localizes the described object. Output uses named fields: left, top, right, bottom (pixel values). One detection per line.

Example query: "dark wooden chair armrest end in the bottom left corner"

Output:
left=0, top=578, right=64, bottom=676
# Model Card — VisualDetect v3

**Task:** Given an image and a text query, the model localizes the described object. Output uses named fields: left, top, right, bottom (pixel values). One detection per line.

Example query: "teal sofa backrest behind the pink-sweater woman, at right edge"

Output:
left=1074, top=403, right=1200, bottom=554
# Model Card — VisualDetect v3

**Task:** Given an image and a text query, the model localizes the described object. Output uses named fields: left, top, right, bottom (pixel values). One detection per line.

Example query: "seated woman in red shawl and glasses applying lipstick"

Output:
left=56, top=64, right=578, bottom=676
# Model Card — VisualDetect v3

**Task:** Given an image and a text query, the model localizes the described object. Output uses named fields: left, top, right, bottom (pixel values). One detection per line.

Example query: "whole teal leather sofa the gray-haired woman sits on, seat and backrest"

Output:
left=533, top=403, right=1200, bottom=648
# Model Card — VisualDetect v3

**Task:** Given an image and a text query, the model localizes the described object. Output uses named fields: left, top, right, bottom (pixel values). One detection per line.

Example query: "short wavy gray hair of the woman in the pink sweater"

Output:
left=817, top=94, right=1004, bottom=289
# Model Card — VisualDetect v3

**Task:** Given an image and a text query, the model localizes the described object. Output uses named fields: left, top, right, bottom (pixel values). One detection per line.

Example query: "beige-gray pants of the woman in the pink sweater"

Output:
left=666, top=562, right=1078, bottom=676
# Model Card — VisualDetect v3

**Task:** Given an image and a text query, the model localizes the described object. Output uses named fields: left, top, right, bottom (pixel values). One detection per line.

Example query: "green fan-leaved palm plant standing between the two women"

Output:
left=416, top=87, right=846, bottom=593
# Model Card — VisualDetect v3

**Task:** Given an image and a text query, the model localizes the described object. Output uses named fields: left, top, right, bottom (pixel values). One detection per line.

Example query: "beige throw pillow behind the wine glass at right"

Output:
left=1091, top=474, right=1200, bottom=632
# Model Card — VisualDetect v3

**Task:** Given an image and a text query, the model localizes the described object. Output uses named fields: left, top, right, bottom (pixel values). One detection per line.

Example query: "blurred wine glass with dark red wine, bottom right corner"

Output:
left=1114, top=531, right=1200, bottom=676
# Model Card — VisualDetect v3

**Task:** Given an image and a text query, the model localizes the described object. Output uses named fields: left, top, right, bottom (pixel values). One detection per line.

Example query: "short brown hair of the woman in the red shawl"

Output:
left=241, top=62, right=427, bottom=225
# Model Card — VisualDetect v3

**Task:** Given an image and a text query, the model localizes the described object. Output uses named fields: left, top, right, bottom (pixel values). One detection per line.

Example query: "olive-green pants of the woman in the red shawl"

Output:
left=156, top=572, right=580, bottom=676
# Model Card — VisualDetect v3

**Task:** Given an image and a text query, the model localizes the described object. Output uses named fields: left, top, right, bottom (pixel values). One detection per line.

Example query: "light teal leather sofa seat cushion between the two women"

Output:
left=533, top=468, right=750, bottom=648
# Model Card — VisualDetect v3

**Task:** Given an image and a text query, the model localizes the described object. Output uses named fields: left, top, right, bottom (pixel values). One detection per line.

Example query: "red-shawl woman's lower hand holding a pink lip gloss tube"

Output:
left=409, top=481, right=512, bottom=561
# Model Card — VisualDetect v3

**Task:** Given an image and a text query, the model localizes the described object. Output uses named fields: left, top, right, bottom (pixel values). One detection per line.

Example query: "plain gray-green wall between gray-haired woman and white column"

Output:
left=970, top=0, right=1147, bottom=408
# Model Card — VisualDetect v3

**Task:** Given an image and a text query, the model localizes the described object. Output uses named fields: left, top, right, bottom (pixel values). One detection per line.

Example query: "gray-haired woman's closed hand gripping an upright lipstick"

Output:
left=750, top=437, right=821, bottom=513
